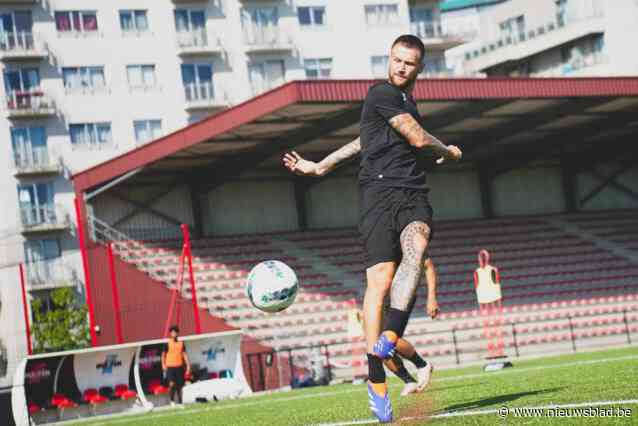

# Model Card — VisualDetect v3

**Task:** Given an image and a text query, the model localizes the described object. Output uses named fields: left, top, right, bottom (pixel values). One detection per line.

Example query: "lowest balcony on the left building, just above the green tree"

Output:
left=25, top=256, right=79, bottom=291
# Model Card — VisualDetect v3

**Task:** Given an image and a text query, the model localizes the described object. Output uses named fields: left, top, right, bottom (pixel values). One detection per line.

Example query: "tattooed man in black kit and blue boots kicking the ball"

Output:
left=284, top=35, right=462, bottom=422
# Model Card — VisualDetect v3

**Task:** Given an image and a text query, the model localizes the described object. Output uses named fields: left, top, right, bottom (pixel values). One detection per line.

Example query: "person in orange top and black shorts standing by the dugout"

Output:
left=162, top=325, right=191, bottom=406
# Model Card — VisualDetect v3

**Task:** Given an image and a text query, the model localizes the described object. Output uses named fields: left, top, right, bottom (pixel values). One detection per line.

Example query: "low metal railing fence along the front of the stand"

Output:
left=245, top=307, right=638, bottom=391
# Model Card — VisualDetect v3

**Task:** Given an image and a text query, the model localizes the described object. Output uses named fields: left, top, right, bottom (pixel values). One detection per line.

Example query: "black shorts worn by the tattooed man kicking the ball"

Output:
left=359, top=185, right=433, bottom=269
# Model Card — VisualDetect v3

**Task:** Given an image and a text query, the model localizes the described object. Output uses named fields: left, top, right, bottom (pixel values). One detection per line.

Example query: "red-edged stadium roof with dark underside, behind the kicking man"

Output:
left=72, top=77, right=638, bottom=193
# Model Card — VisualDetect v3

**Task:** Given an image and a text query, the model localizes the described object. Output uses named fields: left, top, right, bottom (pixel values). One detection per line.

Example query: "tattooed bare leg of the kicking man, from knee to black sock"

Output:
left=390, top=222, right=430, bottom=312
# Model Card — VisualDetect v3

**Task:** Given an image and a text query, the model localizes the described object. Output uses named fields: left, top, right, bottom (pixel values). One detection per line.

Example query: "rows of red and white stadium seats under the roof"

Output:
left=116, top=210, right=638, bottom=374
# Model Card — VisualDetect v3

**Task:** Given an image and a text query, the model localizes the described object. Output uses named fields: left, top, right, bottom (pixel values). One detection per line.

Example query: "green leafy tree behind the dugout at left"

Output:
left=31, top=287, right=90, bottom=353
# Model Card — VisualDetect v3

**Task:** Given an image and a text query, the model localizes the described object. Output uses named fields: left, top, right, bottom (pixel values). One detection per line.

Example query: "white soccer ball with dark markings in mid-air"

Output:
left=246, top=260, right=299, bottom=313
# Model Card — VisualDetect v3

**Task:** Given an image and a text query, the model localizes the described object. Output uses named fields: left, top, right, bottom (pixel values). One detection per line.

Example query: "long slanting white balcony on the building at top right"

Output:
left=465, top=11, right=605, bottom=73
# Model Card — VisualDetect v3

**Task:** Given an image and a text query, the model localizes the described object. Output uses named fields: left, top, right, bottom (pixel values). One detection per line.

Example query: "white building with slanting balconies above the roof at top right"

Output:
left=441, top=0, right=638, bottom=77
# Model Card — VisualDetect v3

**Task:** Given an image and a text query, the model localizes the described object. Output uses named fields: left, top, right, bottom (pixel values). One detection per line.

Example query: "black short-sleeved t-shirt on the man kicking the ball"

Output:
left=359, top=81, right=425, bottom=189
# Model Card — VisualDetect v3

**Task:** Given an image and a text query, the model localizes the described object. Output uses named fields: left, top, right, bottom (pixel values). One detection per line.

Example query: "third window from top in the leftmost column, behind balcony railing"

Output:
left=11, top=127, right=49, bottom=168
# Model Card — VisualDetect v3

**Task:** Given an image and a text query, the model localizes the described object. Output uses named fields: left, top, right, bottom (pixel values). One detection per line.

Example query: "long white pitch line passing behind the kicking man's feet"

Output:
left=84, top=355, right=638, bottom=426
